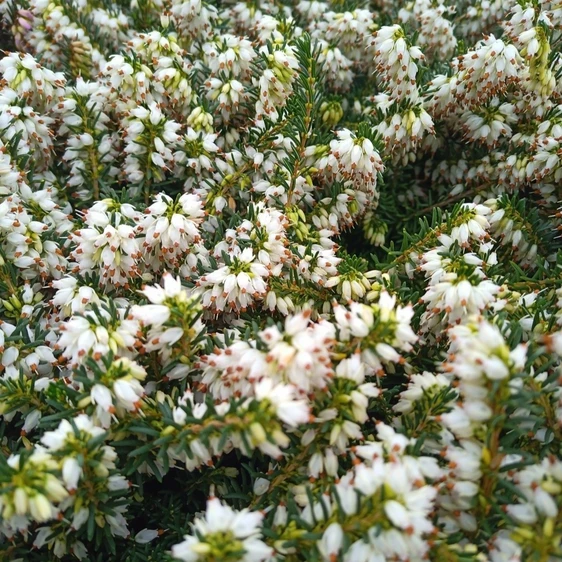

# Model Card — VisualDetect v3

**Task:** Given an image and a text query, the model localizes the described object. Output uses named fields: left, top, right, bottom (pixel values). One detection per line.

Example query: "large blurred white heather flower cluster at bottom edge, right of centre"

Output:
left=302, top=424, right=441, bottom=562
